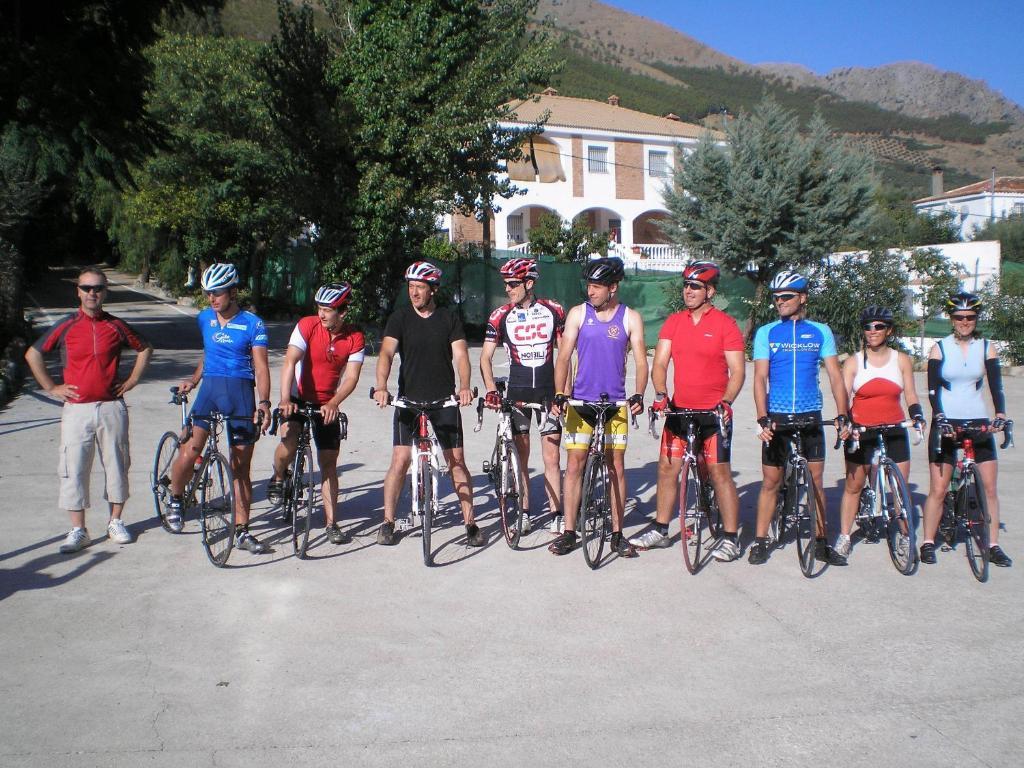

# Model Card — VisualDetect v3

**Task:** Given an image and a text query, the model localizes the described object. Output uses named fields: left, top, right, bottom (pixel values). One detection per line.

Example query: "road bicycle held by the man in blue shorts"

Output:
left=151, top=387, right=239, bottom=568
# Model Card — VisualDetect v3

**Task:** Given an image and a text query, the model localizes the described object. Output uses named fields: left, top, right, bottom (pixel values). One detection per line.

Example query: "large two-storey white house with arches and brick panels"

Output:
left=444, top=88, right=720, bottom=267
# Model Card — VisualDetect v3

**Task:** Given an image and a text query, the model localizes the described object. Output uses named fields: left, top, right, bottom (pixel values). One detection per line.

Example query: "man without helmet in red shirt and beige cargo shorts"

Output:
left=25, top=267, right=153, bottom=554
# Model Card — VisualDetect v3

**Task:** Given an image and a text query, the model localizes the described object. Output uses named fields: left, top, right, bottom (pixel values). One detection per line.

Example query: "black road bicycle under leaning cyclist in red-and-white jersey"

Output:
left=268, top=402, right=348, bottom=560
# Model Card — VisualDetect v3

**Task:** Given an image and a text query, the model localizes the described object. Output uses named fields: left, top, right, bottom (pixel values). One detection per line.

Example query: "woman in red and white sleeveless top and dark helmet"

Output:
left=835, top=306, right=925, bottom=557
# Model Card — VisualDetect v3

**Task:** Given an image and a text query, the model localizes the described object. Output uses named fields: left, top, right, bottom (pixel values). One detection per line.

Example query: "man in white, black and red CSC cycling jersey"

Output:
left=480, top=258, right=565, bottom=535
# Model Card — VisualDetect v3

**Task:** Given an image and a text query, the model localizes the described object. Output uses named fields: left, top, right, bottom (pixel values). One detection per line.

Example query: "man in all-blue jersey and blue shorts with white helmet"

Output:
left=167, top=263, right=270, bottom=553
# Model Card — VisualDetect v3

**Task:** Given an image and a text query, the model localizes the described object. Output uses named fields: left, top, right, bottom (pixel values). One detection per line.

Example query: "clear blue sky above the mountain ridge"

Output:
left=604, top=0, right=1024, bottom=106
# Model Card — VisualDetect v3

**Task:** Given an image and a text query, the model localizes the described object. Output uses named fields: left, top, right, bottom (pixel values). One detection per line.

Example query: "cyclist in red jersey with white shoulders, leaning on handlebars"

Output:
left=267, top=283, right=365, bottom=544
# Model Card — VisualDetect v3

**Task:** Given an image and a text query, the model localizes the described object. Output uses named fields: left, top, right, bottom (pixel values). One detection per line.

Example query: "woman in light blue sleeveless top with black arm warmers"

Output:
left=921, top=292, right=1013, bottom=568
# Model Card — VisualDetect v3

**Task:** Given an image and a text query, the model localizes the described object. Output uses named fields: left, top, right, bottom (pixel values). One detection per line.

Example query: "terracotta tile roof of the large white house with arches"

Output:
left=508, top=93, right=712, bottom=139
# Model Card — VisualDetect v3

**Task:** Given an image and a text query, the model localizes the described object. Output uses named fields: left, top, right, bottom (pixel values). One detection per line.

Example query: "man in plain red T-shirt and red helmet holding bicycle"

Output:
left=630, top=261, right=745, bottom=561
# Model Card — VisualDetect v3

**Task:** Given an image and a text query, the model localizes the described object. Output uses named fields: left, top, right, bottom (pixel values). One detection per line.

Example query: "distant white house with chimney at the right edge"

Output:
left=913, top=171, right=1024, bottom=240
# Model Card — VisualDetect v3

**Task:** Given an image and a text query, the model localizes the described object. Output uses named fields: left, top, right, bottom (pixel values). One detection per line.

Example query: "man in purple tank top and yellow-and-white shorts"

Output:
left=548, top=258, right=647, bottom=557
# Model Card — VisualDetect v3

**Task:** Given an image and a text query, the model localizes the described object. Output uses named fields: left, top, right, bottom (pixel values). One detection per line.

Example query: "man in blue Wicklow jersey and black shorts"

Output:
left=748, top=270, right=850, bottom=565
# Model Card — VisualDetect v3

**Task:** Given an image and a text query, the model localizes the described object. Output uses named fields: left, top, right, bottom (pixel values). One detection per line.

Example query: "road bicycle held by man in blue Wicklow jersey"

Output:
left=768, top=415, right=825, bottom=578
